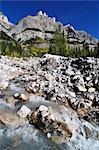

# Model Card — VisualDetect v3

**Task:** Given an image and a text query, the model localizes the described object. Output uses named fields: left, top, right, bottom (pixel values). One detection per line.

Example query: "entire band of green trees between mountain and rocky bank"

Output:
left=0, top=31, right=99, bottom=57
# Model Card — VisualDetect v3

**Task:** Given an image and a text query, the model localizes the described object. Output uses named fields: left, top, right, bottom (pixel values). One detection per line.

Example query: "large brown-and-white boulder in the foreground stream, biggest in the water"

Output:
left=31, top=105, right=72, bottom=143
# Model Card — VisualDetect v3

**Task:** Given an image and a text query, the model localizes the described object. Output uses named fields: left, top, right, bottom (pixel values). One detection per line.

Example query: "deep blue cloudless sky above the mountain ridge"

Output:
left=0, top=0, right=99, bottom=39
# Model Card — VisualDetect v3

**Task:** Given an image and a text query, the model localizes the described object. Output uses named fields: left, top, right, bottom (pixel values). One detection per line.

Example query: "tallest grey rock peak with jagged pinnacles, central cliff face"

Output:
left=10, top=11, right=57, bottom=41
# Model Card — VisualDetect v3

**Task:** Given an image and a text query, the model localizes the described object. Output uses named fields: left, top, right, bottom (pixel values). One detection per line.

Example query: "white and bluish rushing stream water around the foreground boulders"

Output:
left=0, top=82, right=99, bottom=150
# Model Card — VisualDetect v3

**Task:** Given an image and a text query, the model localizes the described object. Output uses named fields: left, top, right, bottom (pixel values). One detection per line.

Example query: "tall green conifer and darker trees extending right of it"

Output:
left=49, top=31, right=99, bottom=57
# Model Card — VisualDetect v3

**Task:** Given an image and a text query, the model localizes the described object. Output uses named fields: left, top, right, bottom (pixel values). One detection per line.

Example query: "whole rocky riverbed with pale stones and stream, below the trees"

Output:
left=0, top=54, right=99, bottom=150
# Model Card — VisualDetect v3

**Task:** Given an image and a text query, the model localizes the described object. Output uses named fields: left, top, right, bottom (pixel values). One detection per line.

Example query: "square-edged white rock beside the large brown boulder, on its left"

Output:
left=17, top=105, right=31, bottom=118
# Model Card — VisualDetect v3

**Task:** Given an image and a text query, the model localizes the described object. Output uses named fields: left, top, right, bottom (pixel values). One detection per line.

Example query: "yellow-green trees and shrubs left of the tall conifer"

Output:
left=0, top=32, right=48, bottom=57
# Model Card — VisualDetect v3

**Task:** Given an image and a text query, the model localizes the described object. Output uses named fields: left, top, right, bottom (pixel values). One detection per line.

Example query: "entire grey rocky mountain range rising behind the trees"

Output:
left=0, top=11, right=98, bottom=56
